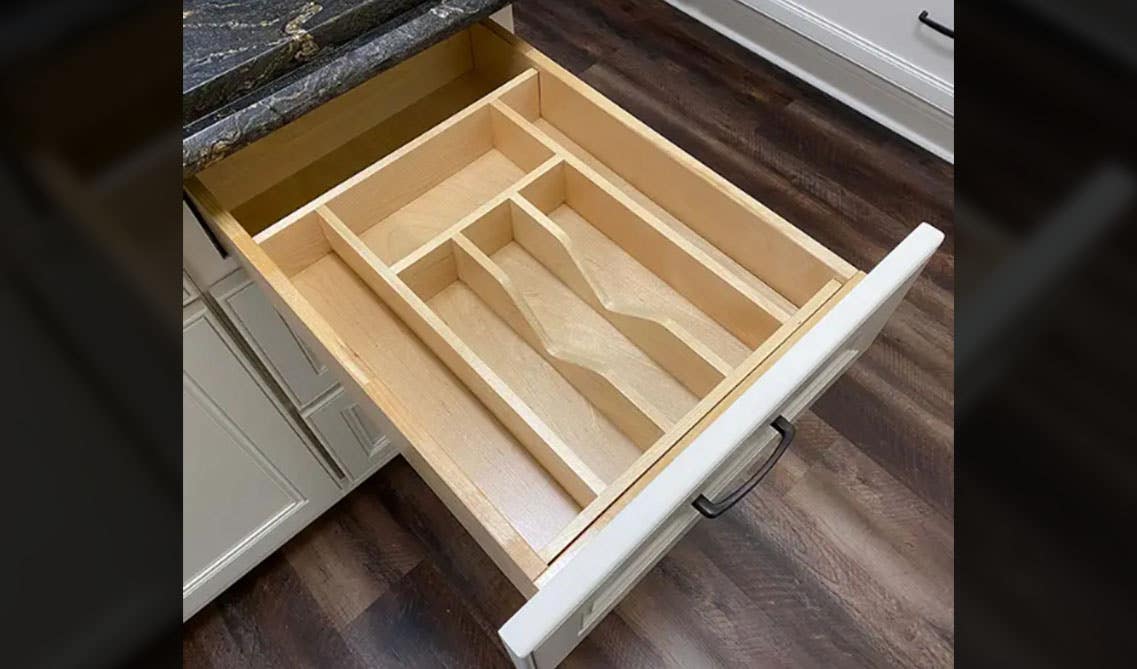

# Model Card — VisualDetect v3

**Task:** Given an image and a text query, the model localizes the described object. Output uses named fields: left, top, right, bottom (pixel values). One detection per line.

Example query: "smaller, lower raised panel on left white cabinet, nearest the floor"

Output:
left=305, top=388, right=402, bottom=481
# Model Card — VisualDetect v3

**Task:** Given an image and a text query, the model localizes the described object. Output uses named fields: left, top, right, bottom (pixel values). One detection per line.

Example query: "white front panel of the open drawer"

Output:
left=500, top=224, right=944, bottom=668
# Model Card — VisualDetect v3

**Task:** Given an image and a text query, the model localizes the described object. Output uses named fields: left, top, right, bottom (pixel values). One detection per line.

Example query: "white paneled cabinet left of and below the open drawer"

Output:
left=182, top=261, right=402, bottom=618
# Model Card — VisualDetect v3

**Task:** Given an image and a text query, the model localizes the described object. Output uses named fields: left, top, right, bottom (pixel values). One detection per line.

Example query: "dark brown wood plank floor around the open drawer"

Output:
left=183, top=0, right=955, bottom=668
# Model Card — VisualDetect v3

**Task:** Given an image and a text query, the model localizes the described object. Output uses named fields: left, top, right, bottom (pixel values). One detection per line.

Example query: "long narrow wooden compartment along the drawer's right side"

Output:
left=504, top=72, right=856, bottom=304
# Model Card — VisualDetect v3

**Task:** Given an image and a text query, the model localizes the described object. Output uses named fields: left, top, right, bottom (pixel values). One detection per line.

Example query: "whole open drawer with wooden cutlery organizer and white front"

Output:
left=186, top=19, right=941, bottom=667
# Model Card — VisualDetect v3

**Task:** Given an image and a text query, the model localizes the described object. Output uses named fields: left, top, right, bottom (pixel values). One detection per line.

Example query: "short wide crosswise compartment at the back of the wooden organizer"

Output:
left=326, top=89, right=553, bottom=265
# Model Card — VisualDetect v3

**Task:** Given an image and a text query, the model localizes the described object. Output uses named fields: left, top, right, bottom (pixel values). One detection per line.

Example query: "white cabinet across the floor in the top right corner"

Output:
left=667, top=0, right=955, bottom=162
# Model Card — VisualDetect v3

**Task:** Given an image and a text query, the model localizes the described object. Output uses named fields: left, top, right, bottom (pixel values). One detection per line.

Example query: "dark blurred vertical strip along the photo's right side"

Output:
left=955, top=0, right=1137, bottom=667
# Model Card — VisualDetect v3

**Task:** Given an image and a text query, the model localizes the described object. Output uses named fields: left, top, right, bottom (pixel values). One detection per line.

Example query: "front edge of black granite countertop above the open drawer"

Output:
left=182, top=0, right=508, bottom=177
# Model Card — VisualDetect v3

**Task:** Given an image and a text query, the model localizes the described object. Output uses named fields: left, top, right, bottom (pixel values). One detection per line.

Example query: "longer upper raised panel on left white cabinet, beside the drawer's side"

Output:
left=209, top=270, right=337, bottom=408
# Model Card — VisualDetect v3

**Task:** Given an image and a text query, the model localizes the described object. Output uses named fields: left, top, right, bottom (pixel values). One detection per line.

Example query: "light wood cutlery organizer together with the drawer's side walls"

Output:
left=189, top=26, right=856, bottom=595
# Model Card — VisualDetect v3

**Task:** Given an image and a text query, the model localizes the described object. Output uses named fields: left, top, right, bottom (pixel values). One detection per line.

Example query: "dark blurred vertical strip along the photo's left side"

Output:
left=0, top=1, right=181, bottom=667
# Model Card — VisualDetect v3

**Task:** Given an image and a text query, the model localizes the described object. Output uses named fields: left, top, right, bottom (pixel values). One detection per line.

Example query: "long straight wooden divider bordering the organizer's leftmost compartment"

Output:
left=317, top=207, right=605, bottom=506
